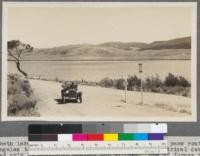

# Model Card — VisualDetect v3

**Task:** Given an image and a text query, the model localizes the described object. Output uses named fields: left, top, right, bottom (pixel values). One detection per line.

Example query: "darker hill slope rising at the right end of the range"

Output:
left=140, top=37, right=191, bottom=50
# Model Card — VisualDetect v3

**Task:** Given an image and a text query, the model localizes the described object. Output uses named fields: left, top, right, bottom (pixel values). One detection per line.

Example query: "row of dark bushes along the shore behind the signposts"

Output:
left=99, top=73, right=191, bottom=97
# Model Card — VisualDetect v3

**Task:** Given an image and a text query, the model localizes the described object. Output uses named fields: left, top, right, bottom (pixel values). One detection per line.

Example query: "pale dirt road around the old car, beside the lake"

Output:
left=30, top=80, right=191, bottom=117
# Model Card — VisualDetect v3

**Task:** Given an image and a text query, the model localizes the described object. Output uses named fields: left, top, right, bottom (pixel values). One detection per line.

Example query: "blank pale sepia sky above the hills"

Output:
left=6, top=4, right=192, bottom=48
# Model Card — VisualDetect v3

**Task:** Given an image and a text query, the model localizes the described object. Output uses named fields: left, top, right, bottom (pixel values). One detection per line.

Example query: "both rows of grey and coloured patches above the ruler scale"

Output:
left=29, top=124, right=167, bottom=141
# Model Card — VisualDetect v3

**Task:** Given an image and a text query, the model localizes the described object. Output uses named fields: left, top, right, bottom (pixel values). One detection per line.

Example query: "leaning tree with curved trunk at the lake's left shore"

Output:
left=7, top=40, right=33, bottom=77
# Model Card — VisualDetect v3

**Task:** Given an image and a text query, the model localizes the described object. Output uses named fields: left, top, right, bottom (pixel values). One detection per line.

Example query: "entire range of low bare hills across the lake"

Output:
left=12, top=37, right=191, bottom=60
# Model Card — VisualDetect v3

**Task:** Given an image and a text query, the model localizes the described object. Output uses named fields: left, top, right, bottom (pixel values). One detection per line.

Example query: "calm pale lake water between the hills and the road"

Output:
left=8, top=60, right=191, bottom=81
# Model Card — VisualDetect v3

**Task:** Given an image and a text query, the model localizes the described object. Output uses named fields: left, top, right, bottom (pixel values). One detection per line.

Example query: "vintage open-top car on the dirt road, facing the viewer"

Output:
left=61, top=82, right=82, bottom=103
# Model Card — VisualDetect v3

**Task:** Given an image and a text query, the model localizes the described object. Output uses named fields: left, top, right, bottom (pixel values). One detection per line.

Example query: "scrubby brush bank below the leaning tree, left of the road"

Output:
left=7, top=74, right=40, bottom=116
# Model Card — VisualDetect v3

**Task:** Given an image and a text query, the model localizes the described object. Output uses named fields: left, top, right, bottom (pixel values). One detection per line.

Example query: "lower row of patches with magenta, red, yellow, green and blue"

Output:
left=29, top=133, right=164, bottom=141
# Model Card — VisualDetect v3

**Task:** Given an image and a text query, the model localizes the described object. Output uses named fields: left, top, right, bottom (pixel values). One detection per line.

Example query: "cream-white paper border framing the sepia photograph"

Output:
left=1, top=2, right=197, bottom=122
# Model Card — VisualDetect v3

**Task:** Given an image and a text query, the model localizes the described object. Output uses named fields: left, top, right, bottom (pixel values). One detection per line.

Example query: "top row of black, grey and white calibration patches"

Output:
left=28, top=123, right=167, bottom=134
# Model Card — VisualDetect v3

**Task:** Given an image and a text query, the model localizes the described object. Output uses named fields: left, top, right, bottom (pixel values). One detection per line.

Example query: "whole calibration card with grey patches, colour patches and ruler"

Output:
left=29, top=124, right=167, bottom=155
